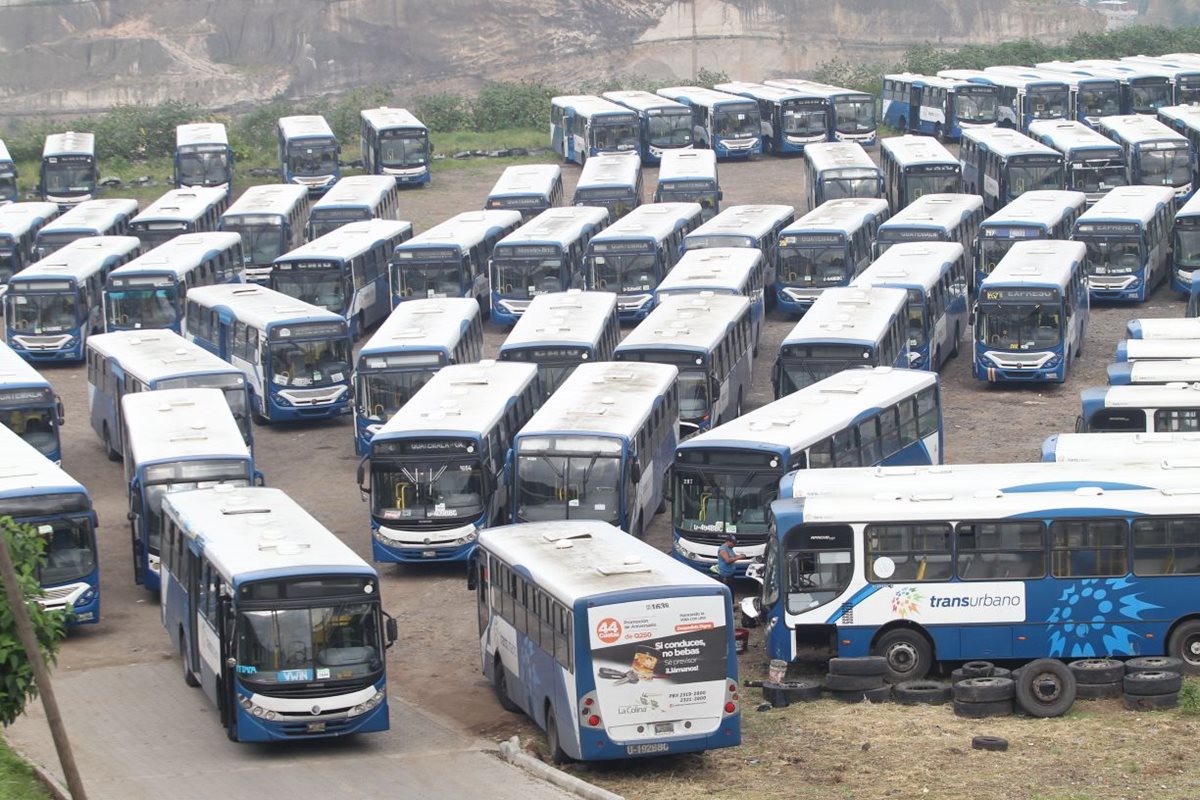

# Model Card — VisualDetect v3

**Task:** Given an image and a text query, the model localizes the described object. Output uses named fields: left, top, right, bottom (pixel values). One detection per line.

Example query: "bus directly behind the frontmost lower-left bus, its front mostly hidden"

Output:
left=121, top=389, right=262, bottom=591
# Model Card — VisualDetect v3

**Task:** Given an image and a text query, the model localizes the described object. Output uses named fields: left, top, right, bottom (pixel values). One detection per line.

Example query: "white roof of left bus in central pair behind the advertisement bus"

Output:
left=371, top=361, right=538, bottom=447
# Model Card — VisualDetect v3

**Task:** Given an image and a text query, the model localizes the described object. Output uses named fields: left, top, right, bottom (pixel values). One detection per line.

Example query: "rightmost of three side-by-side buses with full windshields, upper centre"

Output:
left=583, top=203, right=701, bottom=323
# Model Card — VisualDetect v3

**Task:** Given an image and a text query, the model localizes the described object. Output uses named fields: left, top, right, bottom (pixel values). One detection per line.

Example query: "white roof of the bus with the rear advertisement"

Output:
left=479, top=519, right=724, bottom=606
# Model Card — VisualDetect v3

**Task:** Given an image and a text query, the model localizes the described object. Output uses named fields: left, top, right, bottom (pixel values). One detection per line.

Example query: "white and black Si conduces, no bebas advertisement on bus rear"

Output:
left=588, top=595, right=732, bottom=741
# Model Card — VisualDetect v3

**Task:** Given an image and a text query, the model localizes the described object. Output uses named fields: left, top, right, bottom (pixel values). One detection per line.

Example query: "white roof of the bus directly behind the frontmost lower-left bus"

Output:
left=121, top=389, right=250, bottom=465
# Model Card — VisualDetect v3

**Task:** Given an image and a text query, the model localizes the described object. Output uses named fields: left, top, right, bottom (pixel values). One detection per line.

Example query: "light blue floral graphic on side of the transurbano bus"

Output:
left=1048, top=578, right=1160, bottom=658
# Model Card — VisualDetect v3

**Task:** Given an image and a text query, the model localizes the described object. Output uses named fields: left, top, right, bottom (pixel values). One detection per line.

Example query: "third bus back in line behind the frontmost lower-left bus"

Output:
left=88, top=330, right=254, bottom=461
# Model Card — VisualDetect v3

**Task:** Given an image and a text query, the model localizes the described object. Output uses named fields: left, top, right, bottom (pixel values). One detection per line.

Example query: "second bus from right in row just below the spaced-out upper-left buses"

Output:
left=217, top=184, right=310, bottom=285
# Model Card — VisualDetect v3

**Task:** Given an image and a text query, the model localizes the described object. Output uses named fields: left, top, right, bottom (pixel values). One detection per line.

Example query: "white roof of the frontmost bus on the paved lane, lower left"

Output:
left=163, top=486, right=376, bottom=588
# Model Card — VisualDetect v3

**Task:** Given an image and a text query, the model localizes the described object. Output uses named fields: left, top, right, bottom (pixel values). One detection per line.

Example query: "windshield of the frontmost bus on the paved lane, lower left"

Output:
left=238, top=602, right=383, bottom=691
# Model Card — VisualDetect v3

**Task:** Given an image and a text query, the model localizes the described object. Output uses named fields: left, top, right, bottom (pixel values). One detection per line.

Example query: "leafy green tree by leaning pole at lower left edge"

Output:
left=0, top=517, right=66, bottom=727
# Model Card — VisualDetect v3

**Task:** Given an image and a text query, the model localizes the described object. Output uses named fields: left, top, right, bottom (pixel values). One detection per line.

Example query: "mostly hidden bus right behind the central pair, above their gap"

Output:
left=499, top=289, right=620, bottom=404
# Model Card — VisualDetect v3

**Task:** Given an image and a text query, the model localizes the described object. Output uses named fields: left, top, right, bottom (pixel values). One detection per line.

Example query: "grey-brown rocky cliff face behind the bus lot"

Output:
left=0, top=0, right=1103, bottom=114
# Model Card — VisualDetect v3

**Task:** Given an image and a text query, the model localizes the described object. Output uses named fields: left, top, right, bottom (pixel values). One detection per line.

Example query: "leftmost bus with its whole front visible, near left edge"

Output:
left=4, top=236, right=140, bottom=361
